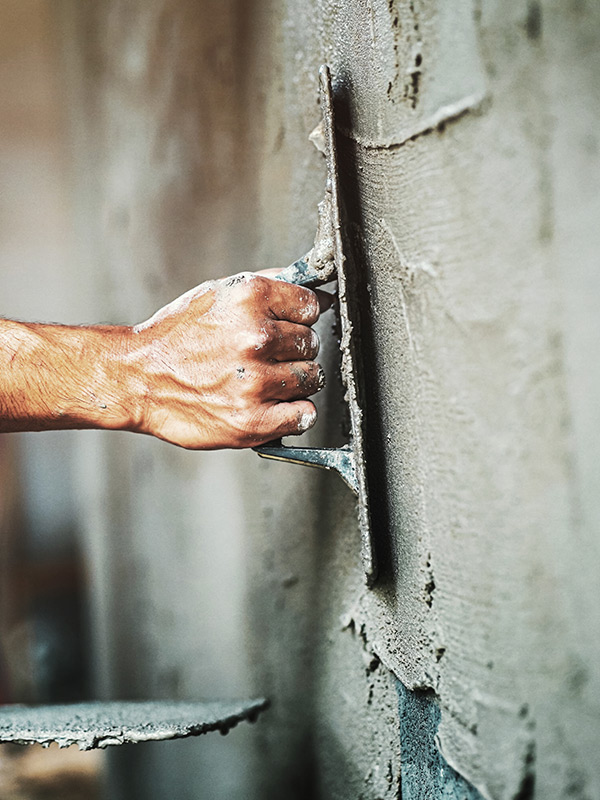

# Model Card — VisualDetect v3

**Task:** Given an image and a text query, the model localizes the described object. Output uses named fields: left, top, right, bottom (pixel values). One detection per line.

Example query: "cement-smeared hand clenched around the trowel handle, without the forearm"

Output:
left=126, top=272, right=331, bottom=450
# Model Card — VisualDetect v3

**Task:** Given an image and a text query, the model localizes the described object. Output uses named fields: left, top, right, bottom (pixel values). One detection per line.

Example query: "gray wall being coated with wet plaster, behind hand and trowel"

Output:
left=57, top=0, right=600, bottom=800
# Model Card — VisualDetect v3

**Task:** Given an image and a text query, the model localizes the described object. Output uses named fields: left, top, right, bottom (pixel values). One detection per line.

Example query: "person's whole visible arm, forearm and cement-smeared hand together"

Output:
left=0, top=273, right=324, bottom=450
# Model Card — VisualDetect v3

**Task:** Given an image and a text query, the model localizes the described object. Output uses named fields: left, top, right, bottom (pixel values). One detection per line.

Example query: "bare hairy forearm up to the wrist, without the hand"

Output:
left=0, top=319, right=139, bottom=433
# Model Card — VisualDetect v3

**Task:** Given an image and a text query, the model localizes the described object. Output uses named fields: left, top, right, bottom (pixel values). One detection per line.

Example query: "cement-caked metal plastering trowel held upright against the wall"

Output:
left=255, top=66, right=376, bottom=586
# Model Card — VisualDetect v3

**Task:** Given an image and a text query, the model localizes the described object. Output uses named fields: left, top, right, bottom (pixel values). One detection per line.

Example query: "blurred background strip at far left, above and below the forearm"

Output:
left=0, top=2, right=88, bottom=701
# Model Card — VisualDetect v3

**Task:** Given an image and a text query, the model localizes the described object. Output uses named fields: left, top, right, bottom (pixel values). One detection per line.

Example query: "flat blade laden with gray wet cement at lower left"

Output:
left=0, top=699, right=268, bottom=750
